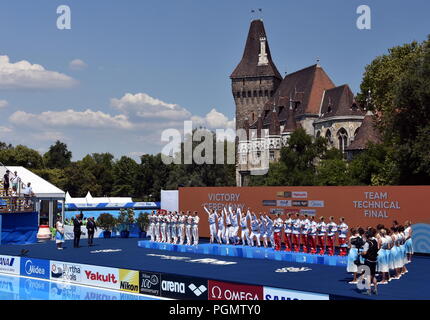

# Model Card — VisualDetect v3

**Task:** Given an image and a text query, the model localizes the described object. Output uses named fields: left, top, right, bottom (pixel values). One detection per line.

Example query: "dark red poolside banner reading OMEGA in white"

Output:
left=208, top=280, right=263, bottom=300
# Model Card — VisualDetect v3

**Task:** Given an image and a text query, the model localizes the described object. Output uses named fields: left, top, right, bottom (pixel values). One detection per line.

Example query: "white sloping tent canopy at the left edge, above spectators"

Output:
left=0, top=166, right=66, bottom=200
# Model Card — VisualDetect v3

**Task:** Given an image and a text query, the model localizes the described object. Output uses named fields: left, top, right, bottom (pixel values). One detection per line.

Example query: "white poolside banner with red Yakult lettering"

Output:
left=82, top=265, right=120, bottom=290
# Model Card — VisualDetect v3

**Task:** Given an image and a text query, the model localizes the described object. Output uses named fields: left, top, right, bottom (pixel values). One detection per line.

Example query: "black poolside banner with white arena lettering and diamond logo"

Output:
left=161, top=274, right=208, bottom=300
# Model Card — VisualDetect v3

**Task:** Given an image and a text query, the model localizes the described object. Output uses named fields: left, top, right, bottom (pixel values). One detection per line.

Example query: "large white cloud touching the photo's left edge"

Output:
left=0, top=56, right=78, bottom=89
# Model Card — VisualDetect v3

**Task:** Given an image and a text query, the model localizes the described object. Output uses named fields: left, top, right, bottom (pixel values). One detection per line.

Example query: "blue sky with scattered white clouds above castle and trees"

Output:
left=0, top=0, right=430, bottom=160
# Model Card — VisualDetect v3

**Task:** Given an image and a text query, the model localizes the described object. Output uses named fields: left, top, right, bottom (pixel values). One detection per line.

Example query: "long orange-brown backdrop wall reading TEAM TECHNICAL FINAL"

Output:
left=179, top=186, right=430, bottom=253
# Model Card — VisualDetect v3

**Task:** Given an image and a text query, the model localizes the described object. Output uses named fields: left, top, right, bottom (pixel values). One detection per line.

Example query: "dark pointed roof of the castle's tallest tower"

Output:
left=230, top=20, right=282, bottom=80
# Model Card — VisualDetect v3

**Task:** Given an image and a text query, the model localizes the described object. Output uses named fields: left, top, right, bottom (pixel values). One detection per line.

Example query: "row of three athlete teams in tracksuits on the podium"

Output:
left=148, top=207, right=348, bottom=256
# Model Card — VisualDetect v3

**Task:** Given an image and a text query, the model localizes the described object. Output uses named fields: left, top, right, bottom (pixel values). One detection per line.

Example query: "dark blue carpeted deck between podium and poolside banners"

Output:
left=0, top=239, right=430, bottom=299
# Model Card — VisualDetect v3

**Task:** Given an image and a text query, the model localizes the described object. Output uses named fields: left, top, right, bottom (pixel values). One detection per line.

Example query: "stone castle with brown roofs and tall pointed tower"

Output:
left=230, top=20, right=372, bottom=186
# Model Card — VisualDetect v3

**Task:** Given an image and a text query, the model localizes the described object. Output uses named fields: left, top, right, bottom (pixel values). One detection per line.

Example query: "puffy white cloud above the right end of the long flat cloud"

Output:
left=111, top=93, right=191, bottom=120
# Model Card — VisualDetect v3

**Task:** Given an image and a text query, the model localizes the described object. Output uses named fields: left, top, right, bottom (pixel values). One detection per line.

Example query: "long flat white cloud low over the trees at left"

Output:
left=9, top=109, right=133, bottom=129
